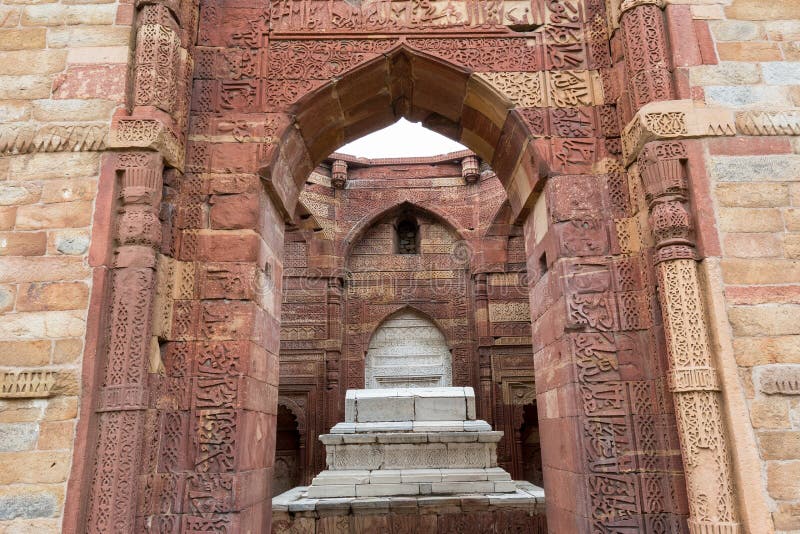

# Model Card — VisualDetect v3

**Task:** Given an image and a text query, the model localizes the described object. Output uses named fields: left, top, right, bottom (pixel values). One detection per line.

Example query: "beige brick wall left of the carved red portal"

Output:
left=0, top=0, right=132, bottom=533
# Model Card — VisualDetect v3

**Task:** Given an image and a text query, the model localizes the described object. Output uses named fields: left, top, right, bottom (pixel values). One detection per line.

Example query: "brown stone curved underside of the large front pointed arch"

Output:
left=259, top=44, right=550, bottom=223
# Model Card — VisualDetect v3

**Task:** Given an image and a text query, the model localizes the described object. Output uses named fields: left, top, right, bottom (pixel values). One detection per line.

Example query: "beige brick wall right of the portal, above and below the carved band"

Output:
left=677, top=0, right=800, bottom=532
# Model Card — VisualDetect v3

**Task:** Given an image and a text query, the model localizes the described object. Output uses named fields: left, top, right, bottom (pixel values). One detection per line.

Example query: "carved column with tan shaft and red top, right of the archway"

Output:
left=639, top=142, right=740, bottom=534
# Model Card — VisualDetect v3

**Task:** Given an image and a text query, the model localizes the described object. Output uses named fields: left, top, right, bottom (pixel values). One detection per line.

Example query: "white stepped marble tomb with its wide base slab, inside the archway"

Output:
left=272, top=387, right=544, bottom=532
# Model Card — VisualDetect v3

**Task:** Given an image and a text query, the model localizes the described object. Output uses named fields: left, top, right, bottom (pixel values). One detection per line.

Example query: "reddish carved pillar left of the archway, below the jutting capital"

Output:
left=85, top=152, right=163, bottom=532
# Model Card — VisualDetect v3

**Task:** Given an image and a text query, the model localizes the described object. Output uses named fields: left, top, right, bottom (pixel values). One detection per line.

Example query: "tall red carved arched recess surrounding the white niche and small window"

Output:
left=344, top=202, right=474, bottom=387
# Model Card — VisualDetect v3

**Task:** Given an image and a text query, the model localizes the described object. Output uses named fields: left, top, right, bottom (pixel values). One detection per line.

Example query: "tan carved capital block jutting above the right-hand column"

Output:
left=622, top=100, right=736, bottom=165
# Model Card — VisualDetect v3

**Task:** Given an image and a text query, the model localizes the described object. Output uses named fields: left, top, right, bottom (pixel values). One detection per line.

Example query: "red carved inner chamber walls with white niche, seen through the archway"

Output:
left=279, top=123, right=542, bottom=492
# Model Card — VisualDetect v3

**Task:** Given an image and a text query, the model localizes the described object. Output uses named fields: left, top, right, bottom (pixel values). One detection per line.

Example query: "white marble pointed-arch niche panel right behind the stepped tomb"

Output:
left=364, top=306, right=453, bottom=389
